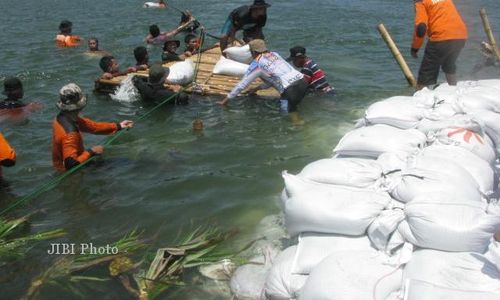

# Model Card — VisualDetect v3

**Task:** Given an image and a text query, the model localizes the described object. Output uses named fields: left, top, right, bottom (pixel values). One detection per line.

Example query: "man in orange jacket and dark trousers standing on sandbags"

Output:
left=411, top=0, right=467, bottom=90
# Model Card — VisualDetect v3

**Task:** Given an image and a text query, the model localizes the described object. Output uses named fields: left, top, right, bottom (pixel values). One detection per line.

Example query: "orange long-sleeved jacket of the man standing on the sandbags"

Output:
left=411, top=0, right=467, bottom=49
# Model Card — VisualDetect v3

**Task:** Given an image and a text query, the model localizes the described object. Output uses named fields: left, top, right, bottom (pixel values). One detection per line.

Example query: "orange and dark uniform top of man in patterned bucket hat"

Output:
left=52, top=113, right=121, bottom=171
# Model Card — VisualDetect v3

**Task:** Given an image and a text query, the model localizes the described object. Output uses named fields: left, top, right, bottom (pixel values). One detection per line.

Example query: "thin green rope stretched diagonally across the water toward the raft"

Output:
left=0, top=90, right=182, bottom=215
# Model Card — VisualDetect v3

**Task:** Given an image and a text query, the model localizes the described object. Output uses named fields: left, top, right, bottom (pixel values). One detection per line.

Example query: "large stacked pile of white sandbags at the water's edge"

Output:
left=231, top=80, right=500, bottom=300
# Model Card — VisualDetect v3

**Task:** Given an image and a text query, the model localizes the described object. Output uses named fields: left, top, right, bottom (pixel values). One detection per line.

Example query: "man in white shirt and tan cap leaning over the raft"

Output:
left=217, top=39, right=309, bottom=122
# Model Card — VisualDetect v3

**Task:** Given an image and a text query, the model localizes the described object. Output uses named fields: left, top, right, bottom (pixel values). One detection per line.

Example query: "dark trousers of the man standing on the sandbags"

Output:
left=418, top=40, right=465, bottom=86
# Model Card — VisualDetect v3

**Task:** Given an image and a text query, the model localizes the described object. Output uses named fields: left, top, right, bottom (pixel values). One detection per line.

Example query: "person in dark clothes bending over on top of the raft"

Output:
left=220, top=0, right=271, bottom=55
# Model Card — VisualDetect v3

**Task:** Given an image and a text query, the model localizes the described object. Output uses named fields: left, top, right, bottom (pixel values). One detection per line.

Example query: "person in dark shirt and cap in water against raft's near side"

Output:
left=133, top=64, right=189, bottom=105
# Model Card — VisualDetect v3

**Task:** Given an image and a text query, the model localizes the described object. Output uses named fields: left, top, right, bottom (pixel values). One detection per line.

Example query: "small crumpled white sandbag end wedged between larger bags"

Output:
left=367, top=208, right=405, bottom=251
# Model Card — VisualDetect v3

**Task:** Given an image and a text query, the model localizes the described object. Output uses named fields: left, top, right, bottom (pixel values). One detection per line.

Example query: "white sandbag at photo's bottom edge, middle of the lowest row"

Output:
left=299, top=251, right=403, bottom=300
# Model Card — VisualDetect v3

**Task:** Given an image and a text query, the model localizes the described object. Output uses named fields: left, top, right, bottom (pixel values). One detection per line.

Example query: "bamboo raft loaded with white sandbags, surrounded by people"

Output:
left=95, top=45, right=280, bottom=98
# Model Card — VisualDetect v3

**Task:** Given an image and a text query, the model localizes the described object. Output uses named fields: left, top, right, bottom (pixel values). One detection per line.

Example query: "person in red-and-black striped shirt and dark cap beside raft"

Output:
left=287, top=46, right=333, bottom=93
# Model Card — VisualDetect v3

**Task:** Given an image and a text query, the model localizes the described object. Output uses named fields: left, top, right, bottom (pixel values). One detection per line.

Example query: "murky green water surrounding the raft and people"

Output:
left=0, top=0, right=500, bottom=299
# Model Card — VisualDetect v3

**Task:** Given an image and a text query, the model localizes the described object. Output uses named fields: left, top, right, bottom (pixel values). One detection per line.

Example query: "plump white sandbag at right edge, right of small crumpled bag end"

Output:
left=398, top=193, right=500, bottom=253
